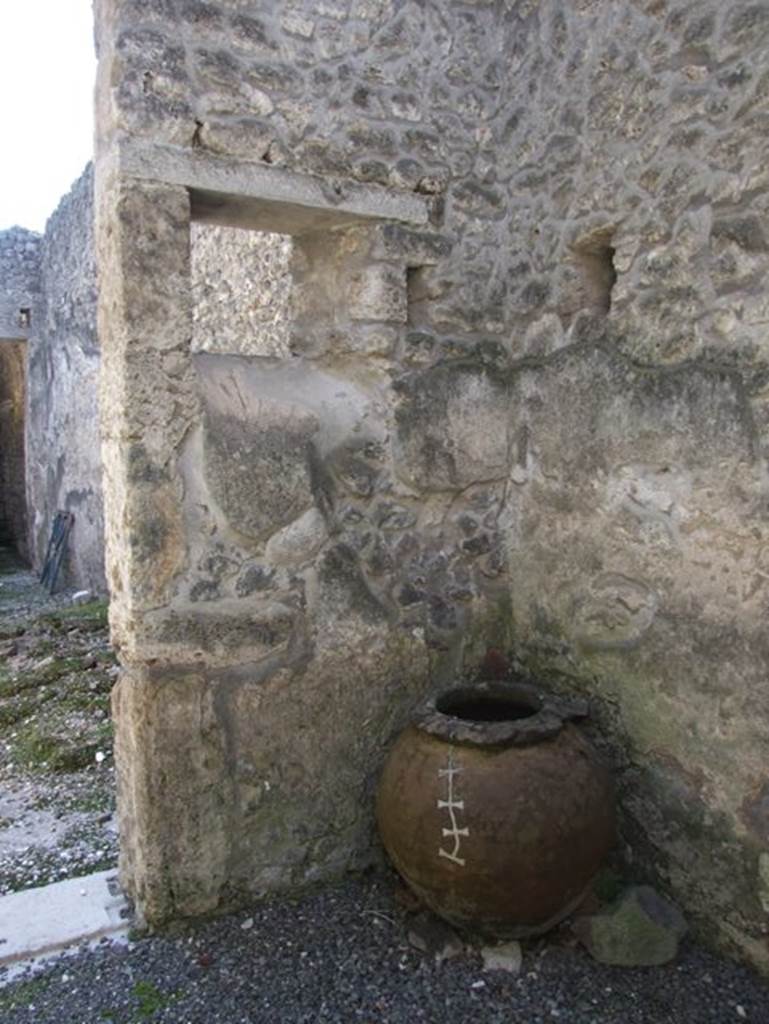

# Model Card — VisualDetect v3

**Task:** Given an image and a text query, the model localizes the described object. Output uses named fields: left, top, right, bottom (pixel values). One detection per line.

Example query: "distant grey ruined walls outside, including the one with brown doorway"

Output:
left=0, top=175, right=105, bottom=593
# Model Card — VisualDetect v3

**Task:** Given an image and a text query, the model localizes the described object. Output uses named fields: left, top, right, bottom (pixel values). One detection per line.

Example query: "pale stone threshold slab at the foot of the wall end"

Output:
left=0, top=871, right=130, bottom=968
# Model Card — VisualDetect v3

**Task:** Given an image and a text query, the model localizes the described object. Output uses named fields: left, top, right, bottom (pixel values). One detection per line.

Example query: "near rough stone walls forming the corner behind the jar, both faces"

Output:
left=96, top=0, right=769, bottom=969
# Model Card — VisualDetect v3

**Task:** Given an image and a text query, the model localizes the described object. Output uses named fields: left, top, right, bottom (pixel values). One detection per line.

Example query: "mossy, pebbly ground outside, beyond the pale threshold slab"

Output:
left=0, top=548, right=118, bottom=896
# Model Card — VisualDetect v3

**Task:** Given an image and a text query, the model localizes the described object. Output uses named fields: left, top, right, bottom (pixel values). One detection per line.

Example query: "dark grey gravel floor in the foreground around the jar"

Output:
left=0, top=874, right=769, bottom=1024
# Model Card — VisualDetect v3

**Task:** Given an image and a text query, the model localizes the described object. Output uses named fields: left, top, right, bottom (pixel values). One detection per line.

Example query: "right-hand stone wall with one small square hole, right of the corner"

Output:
left=499, top=3, right=769, bottom=970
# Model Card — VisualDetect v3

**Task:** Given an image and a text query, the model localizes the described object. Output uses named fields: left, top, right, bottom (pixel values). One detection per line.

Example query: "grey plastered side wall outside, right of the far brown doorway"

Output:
left=27, top=168, right=105, bottom=592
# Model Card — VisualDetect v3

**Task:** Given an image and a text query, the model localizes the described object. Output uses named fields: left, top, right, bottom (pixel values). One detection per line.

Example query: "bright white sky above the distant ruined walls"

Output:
left=0, top=0, right=96, bottom=231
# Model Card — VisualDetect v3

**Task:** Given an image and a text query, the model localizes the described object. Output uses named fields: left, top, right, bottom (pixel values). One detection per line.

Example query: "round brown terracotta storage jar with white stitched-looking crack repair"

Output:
left=377, top=683, right=614, bottom=938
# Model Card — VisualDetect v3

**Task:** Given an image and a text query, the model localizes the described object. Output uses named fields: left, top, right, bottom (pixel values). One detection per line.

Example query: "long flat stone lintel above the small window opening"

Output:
left=107, top=142, right=428, bottom=234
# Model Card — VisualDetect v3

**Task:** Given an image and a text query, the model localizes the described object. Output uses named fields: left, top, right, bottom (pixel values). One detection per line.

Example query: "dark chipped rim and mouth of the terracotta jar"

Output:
left=414, top=681, right=589, bottom=746
